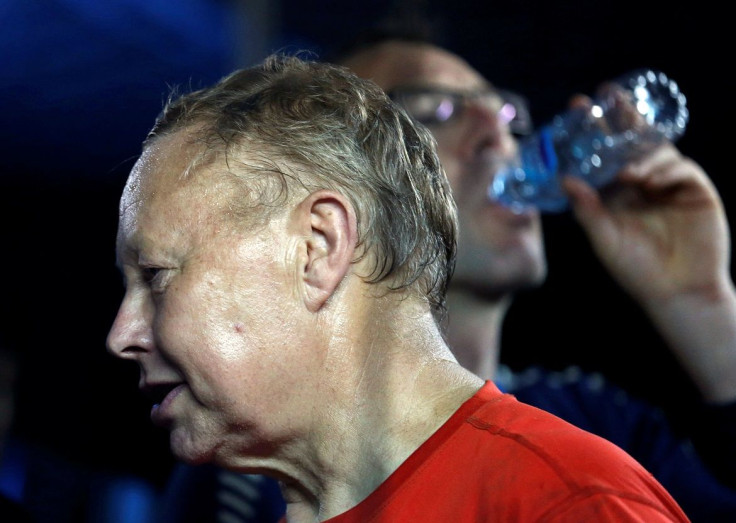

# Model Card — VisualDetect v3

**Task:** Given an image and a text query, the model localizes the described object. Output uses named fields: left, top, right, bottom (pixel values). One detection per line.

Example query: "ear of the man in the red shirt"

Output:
left=295, top=190, right=358, bottom=312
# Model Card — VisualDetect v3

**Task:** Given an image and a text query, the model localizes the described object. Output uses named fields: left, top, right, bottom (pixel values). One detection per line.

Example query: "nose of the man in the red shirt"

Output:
left=107, top=293, right=154, bottom=360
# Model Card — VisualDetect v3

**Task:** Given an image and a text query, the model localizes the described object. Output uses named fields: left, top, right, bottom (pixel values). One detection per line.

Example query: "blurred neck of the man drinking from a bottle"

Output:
left=447, top=289, right=512, bottom=379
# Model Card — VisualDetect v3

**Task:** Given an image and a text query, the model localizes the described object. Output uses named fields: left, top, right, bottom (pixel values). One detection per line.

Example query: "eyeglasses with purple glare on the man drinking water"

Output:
left=388, top=87, right=533, bottom=136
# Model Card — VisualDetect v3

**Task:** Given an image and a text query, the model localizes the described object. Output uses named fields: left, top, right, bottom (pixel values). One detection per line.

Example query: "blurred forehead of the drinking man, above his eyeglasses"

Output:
left=345, top=42, right=488, bottom=91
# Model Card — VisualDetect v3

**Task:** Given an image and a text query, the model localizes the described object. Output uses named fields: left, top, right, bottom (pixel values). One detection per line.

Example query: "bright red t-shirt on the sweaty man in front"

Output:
left=284, top=382, right=689, bottom=523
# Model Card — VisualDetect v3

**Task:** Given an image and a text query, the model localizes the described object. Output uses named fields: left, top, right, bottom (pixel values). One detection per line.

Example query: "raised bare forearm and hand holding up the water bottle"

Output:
left=564, top=144, right=736, bottom=484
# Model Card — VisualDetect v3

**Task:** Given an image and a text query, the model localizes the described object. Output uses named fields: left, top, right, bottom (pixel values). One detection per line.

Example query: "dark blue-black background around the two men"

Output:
left=0, top=0, right=736, bottom=496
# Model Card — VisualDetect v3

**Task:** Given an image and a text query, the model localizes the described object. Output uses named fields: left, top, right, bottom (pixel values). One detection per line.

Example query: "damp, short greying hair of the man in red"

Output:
left=144, top=54, right=457, bottom=321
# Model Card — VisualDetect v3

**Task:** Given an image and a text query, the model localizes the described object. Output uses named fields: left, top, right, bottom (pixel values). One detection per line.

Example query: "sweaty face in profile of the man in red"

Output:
left=108, top=131, right=328, bottom=462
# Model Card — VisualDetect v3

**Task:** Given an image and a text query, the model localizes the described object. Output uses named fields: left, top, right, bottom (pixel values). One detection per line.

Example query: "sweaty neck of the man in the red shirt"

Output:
left=280, top=289, right=483, bottom=521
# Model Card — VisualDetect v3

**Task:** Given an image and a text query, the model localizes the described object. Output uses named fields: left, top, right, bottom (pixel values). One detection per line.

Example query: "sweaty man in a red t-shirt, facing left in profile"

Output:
left=108, top=52, right=687, bottom=522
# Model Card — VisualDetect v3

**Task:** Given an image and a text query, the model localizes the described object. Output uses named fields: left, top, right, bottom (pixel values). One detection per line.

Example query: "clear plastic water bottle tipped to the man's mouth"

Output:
left=488, top=69, right=689, bottom=212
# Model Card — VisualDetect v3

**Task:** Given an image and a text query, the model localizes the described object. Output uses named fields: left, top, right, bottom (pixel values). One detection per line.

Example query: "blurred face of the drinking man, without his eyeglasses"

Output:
left=344, top=41, right=546, bottom=294
